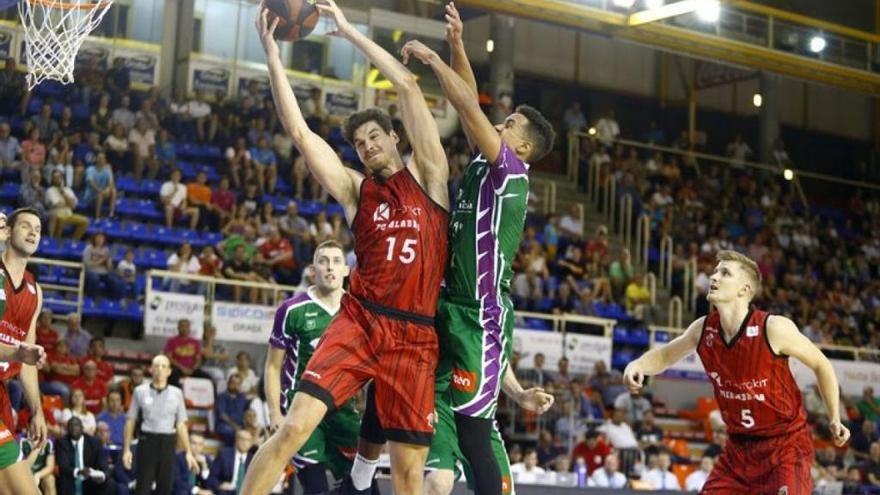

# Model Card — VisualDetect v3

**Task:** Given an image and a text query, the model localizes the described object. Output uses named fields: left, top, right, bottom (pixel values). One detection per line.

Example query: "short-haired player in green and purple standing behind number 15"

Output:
left=264, top=241, right=360, bottom=495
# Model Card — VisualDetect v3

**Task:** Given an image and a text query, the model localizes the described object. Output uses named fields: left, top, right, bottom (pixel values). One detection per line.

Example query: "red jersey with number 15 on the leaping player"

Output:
left=349, top=168, right=449, bottom=317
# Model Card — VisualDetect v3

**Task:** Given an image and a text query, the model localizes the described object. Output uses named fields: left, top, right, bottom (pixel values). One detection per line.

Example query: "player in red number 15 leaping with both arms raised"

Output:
left=242, top=0, right=449, bottom=495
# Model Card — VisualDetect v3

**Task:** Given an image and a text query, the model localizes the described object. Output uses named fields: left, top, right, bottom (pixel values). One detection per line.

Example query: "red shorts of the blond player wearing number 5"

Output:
left=700, top=427, right=813, bottom=495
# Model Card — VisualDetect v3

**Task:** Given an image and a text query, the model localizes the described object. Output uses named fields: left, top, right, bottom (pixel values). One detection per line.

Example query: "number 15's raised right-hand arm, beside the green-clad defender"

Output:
left=315, top=0, right=449, bottom=190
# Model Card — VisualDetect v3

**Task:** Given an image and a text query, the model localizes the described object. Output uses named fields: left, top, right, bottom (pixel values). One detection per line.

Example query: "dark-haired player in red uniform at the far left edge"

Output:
left=0, top=208, right=47, bottom=495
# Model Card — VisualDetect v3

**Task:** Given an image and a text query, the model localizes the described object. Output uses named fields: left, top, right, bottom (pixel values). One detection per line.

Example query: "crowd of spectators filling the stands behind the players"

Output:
left=0, top=56, right=880, bottom=493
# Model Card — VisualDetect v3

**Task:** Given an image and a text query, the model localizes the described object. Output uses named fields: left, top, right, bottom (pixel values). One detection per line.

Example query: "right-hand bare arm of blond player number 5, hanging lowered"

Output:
left=767, top=316, right=849, bottom=447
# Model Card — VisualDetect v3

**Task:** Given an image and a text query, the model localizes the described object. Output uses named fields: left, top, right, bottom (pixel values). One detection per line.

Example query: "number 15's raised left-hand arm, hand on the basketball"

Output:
left=256, top=8, right=363, bottom=223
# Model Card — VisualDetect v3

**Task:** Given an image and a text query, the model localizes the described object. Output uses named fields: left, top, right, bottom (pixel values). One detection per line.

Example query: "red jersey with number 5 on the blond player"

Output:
left=697, top=309, right=807, bottom=437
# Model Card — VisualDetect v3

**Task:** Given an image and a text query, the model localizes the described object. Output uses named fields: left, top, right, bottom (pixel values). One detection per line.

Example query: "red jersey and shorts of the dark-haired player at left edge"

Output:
left=0, top=261, right=39, bottom=442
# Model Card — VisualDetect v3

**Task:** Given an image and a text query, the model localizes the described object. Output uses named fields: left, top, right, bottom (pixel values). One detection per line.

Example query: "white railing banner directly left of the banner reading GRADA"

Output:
left=144, top=291, right=205, bottom=339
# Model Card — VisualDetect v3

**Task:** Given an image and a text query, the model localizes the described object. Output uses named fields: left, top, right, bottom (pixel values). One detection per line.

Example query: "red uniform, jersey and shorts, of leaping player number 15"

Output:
left=300, top=169, right=449, bottom=445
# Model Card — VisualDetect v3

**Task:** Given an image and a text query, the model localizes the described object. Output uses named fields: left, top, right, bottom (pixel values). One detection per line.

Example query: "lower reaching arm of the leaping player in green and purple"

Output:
left=403, top=41, right=501, bottom=163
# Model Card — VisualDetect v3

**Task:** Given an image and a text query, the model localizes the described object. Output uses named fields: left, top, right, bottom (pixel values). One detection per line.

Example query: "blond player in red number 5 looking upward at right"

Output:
left=624, top=251, right=849, bottom=495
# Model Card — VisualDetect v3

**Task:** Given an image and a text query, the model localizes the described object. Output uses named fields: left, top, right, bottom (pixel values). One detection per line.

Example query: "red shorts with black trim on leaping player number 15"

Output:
left=299, top=295, right=438, bottom=446
